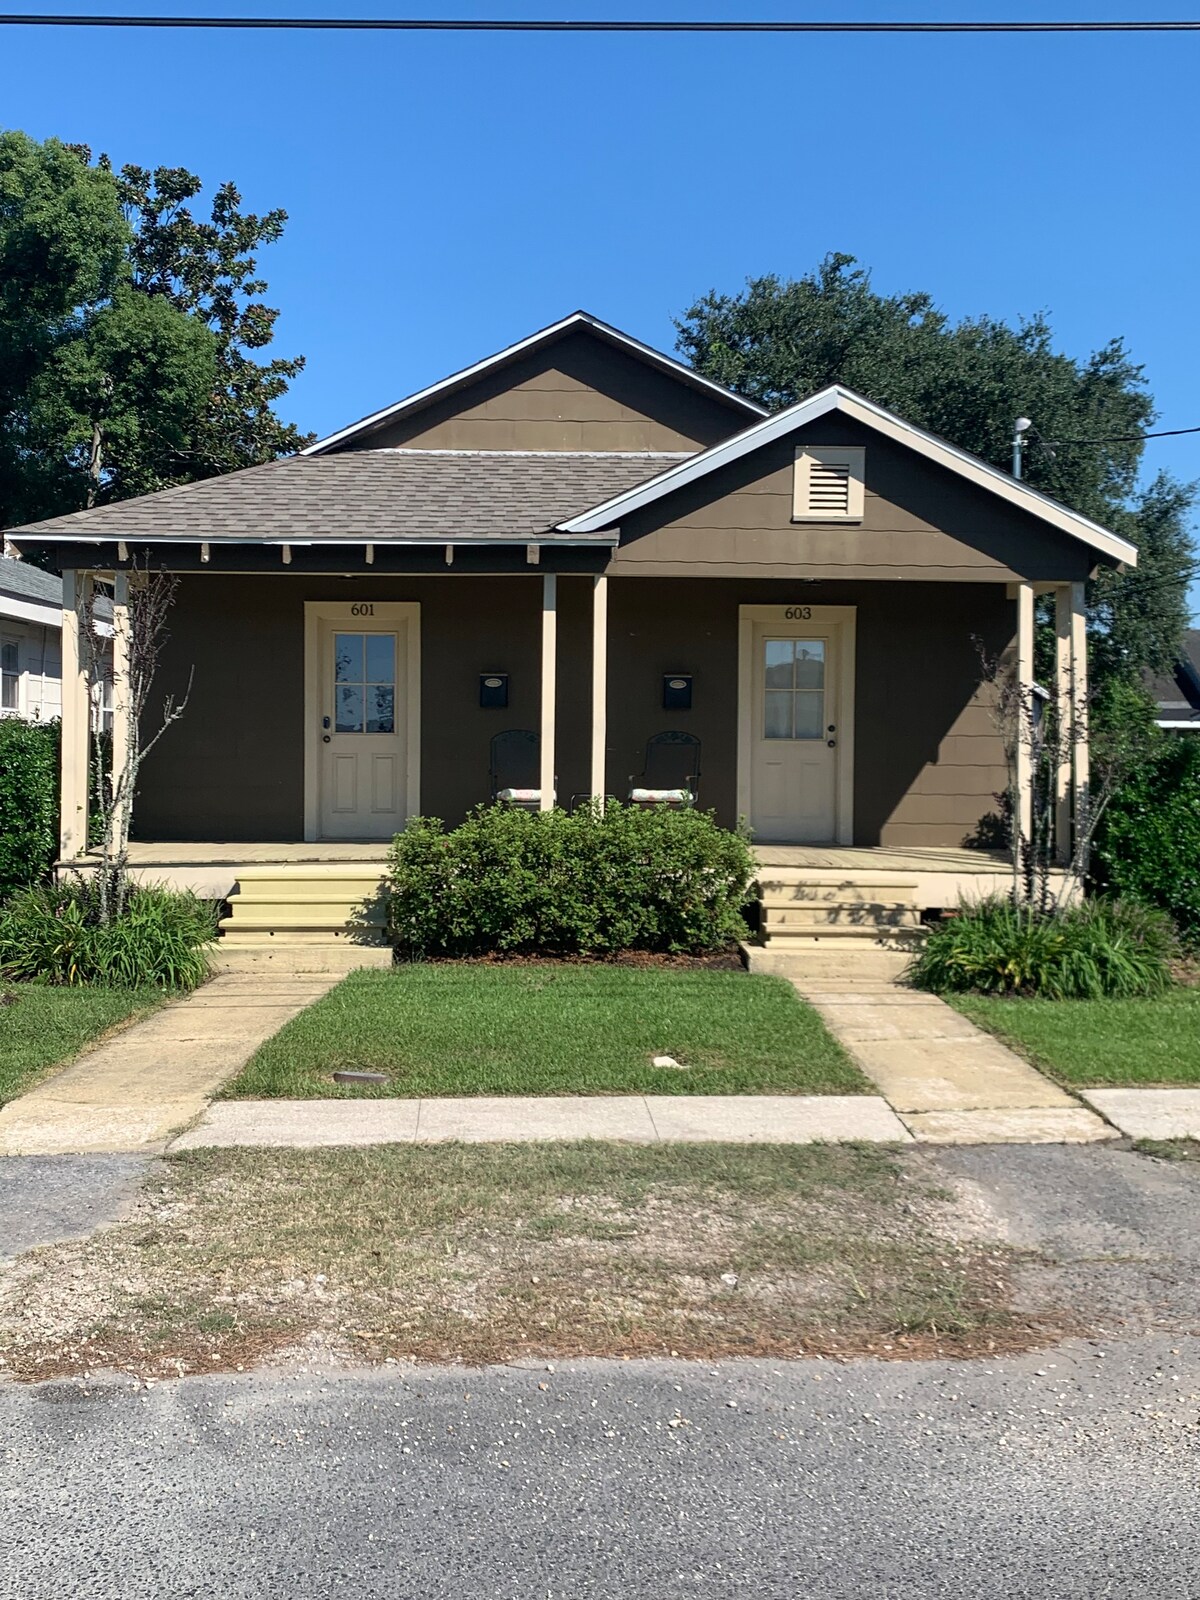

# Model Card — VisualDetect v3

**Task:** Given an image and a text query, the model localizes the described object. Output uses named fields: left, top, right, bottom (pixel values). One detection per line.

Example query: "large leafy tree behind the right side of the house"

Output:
left=677, top=254, right=1195, bottom=680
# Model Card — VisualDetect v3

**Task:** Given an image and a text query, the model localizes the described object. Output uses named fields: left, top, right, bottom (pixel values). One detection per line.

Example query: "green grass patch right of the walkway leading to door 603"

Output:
left=946, top=989, right=1200, bottom=1085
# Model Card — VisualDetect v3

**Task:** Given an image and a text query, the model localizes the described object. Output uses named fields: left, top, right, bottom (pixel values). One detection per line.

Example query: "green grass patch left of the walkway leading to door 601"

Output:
left=0, top=984, right=163, bottom=1104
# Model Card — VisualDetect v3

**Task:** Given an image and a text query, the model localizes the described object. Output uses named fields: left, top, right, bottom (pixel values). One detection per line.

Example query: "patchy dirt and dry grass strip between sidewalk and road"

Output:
left=0, top=1146, right=1072, bottom=1379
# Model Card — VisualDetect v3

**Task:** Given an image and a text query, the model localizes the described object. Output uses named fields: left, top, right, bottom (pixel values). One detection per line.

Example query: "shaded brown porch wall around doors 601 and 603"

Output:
left=143, top=574, right=1014, bottom=846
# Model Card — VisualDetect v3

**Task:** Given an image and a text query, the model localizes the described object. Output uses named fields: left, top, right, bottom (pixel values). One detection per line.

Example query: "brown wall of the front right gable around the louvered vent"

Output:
left=613, top=416, right=1094, bottom=584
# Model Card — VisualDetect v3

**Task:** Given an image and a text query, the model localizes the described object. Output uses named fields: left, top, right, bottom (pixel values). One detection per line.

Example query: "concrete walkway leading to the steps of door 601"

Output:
left=0, top=970, right=342, bottom=1155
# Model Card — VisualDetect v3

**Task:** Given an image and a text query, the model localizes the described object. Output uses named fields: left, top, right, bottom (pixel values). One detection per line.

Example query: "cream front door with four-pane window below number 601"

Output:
left=318, top=606, right=408, bottom=840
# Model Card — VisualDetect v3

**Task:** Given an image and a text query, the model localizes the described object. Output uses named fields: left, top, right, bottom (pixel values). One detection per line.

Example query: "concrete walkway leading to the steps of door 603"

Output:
left=752, top=946, right=1114, bottom=1144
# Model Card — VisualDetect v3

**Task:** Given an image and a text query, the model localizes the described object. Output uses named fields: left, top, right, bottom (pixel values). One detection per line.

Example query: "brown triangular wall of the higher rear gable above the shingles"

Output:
left=346, top=333, right=754, bottom=451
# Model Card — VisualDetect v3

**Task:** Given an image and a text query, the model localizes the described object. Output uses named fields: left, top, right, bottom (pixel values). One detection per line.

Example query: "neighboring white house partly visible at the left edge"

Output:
left=0, top=555, right=112, bottom=728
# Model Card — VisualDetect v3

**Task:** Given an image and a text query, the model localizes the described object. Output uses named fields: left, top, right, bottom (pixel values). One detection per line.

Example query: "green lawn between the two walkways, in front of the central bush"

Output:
left=224, top=963, right=869, bottom=1098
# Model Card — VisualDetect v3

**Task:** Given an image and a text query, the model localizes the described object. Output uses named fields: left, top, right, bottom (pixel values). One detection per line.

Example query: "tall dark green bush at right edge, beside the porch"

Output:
left=1093, top=734, right=1200, bottom=946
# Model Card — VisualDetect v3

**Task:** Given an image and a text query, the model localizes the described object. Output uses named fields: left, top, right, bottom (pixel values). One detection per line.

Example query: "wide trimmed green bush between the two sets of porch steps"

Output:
left=389, top=802, right=754, bottom=957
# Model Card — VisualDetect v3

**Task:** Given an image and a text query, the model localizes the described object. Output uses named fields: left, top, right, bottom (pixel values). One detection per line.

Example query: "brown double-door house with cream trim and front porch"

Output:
left=2, top=312, right=1136, bottom=942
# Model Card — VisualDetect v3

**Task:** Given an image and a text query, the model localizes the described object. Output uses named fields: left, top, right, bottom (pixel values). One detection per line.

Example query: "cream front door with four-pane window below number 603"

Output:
left=750, top=620, right=842, bottom=845
